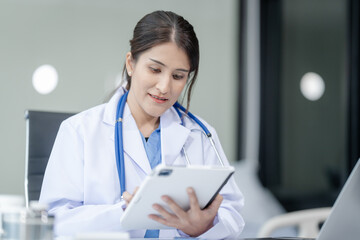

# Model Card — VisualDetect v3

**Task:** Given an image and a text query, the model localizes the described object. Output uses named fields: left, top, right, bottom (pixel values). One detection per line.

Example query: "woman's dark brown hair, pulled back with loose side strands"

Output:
left=123, top=11, right=200, bottom=109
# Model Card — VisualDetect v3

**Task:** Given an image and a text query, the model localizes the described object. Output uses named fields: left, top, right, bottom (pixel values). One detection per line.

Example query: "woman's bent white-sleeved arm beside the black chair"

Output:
left=40, top=120, right=123, bottom=236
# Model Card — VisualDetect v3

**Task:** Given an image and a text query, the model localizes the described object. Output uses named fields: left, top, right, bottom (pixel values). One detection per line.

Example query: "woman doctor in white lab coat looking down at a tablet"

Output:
left=40, top=11, right=244, bottom=239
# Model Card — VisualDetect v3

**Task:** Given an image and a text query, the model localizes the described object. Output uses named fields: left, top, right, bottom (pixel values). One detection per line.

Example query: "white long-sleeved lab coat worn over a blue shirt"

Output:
left=40, top=88, right=244, bottom=239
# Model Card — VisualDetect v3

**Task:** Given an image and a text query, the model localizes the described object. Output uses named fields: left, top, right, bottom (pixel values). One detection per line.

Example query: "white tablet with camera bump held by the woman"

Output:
left=120, top=165, right=235, bottom=230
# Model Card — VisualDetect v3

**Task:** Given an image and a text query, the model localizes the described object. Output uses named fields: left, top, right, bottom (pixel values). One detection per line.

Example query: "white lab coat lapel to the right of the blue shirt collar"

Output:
left=160, top=108, right=190, bottom=165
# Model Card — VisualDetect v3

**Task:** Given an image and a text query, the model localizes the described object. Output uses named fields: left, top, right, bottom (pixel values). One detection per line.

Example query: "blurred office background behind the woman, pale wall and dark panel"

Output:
left=0, top=0, right=360, bottom=237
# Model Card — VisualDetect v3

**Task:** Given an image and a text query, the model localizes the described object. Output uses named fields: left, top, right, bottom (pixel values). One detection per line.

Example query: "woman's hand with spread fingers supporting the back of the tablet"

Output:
left=149, top=188, right=223, bottom=237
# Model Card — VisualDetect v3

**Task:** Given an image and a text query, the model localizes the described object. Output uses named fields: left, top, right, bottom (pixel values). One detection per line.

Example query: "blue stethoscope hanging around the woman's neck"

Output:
left=115, top=91, right=224, bottom=196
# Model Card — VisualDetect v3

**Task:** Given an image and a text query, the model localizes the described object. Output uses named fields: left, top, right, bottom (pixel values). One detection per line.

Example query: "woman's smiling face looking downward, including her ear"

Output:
left=126, top=42, right=190, bottom=120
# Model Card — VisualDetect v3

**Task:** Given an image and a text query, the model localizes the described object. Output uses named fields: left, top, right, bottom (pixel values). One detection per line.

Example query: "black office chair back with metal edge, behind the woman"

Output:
left=25, top=110, right=74, bottom=207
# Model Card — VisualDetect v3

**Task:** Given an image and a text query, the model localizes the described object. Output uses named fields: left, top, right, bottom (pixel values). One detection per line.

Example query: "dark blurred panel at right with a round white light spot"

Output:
left=259, top=0, right=360, bottom=211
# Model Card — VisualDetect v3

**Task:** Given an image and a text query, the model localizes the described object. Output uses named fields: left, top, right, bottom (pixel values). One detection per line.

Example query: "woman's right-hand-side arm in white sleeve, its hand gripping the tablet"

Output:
left=150, top=124, right=244, bottom=239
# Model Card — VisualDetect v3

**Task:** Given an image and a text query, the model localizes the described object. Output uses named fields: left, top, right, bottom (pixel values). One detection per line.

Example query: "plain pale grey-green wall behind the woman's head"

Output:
left=0, top=0, right=238, bottom=194
